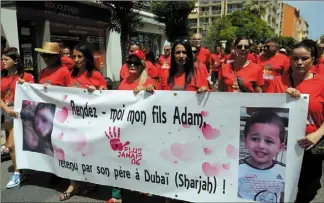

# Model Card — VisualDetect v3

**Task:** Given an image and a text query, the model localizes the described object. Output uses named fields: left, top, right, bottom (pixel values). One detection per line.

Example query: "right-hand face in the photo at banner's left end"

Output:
left=35, top=108, right=53, bottom=137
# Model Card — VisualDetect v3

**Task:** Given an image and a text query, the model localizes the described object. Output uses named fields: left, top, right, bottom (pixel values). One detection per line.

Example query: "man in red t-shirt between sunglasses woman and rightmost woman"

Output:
left=259, top=39, right=290, bottom=91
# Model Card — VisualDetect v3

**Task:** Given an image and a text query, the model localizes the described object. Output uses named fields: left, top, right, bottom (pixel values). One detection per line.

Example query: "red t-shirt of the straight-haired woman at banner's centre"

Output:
left=162, top=71, right=208, bottom=91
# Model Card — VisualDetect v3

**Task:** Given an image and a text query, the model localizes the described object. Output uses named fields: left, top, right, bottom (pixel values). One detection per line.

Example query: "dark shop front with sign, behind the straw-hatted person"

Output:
left=1, top=1, right=111, bottom=81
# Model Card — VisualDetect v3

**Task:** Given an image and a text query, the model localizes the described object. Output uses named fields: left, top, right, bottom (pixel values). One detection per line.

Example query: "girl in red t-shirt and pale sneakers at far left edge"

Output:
left=1, top=48, right=34, bottom=188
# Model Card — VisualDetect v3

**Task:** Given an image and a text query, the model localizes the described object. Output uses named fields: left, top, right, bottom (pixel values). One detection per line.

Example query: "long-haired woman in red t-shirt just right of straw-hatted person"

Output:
left=68, top=44, right=107, bottom=92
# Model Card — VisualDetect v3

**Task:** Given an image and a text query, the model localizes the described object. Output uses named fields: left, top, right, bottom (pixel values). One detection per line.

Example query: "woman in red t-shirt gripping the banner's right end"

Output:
left=269, top=40, right=324, bottom=203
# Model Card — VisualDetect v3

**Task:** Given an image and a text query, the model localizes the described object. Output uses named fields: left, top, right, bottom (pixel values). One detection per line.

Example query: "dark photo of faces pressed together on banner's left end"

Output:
left=20, top=100, right=56, bottom=156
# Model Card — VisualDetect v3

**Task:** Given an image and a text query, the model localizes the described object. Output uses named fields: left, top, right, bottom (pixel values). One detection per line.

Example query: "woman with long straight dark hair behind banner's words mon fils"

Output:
left=162, top=40, right=208, bottom=93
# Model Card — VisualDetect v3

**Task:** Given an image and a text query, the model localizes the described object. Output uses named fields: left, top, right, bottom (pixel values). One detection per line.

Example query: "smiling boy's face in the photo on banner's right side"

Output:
left=244, top=123, right=285, bottom=164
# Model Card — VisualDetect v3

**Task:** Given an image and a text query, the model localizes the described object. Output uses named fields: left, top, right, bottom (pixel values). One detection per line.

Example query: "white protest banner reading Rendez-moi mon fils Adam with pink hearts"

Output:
left=15, top=84, right=308, bottom=202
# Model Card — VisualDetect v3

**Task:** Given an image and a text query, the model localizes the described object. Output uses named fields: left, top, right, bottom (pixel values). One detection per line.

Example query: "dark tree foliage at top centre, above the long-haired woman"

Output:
left=151, top=1, right=195, bottom=42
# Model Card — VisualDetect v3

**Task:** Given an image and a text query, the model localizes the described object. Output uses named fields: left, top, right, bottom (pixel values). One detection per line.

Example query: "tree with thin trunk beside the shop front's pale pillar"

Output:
left=102, top=1, right=144, bottom=63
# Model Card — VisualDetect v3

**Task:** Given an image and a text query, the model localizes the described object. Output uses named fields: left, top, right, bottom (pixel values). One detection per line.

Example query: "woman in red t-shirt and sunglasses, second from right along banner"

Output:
left=218, top=37, right=264, bottom=93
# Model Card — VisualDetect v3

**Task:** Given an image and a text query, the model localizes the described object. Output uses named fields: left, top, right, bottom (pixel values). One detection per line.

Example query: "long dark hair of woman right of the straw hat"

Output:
left=71, top=43, right=97, bottom=77
